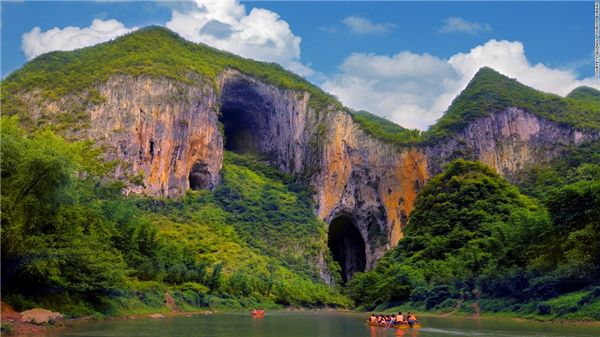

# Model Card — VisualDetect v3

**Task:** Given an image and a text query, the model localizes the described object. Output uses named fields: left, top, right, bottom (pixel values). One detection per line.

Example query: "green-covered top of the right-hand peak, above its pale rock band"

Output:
left=425, top=67, right=600, bottom=142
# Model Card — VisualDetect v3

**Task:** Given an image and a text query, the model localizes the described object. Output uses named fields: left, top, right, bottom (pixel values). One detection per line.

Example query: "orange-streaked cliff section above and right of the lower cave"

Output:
left=312, top=112, right=429, bottom=269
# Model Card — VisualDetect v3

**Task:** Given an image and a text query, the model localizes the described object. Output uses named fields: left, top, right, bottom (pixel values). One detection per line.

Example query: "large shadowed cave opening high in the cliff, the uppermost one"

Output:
left=219, top=78, right=273, bottom=154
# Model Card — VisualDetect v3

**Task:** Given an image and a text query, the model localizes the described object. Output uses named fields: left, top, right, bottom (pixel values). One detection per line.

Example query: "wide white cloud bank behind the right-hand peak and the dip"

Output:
left=322, top=40, right=600, bottom=129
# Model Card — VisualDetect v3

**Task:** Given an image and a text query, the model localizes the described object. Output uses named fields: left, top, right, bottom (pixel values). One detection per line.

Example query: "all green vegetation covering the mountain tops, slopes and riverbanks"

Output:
left=0, top=27, right=600, bottom=319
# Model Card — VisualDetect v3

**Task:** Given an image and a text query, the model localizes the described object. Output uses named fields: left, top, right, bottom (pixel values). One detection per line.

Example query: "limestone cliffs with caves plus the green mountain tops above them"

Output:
left=2, top=27, right=600, bottom=280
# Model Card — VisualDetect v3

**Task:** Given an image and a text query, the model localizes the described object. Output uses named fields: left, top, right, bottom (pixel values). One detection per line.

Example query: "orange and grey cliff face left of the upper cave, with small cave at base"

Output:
left=87, top=76, right=223, bottom=197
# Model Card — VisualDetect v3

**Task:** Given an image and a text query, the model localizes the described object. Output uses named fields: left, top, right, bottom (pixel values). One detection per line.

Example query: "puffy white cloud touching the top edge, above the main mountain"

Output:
left=166, top=0, right=313, bottom=76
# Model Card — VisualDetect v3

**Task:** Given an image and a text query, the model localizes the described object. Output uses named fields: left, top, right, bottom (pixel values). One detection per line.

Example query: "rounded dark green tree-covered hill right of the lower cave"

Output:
left=392, top=159, right=547, bottom=286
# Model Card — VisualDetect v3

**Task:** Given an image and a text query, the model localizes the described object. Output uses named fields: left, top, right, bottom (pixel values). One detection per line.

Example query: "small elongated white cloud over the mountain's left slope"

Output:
left=21, top=19, right=136, bottom=59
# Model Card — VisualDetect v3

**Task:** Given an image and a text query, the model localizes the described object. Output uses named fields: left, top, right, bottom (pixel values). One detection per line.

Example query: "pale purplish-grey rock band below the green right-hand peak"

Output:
left=427, top=107, right=600, bottom=180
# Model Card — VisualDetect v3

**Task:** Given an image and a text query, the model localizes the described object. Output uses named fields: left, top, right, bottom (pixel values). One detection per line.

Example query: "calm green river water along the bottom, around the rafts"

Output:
left=52, top=312, right=600, bottom=337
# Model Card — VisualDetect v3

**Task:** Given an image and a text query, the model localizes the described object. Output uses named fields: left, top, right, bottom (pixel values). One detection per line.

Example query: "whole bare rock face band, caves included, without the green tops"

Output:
left=16, top=70, right=600, bottom=279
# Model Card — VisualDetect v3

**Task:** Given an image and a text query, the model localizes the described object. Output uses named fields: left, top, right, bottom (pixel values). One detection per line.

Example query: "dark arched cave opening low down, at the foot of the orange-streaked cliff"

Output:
left=327, top=215, right=367, bottom=283
